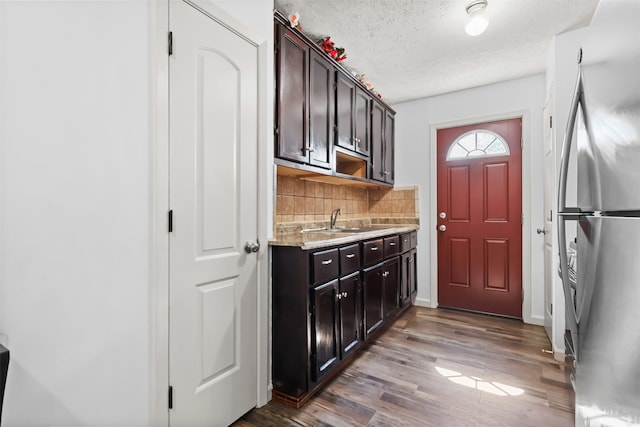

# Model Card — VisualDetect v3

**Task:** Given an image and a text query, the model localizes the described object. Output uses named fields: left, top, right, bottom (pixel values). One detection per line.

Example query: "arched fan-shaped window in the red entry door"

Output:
left=447, top=129, right=510, bottom=161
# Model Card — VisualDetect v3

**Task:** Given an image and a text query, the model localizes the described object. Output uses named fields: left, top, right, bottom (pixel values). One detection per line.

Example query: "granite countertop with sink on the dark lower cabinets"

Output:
left=269, top=224, right=418, bottom=249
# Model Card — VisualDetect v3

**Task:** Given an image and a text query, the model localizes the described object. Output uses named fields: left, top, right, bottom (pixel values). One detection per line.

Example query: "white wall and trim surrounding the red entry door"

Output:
left=394, top=74, right=545, bottom=324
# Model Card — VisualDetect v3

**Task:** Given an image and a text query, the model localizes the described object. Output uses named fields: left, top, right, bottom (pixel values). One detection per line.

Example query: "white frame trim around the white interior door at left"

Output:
left=148, top=0, right=273, bottom=426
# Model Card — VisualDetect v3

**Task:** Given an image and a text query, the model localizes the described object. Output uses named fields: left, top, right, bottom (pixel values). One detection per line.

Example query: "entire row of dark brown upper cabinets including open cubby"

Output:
left=274, top=13, right=395, bottom=186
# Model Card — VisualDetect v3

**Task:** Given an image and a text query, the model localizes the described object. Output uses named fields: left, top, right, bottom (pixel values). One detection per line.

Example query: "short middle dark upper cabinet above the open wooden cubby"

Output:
left=336, top=71, right=371, bottom=156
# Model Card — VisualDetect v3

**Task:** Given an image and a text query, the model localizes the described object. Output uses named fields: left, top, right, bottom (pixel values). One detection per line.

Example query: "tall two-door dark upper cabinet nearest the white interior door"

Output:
left=275, top=25, right=335, bottom=169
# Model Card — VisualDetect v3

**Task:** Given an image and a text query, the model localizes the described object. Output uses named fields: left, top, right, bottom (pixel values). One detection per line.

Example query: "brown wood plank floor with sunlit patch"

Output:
left=234, top=307, right=574, bottom=427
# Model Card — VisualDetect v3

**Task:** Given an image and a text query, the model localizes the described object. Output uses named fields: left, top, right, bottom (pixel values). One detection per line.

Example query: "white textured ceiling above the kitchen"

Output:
left=275, top=0, right=599, bottom=104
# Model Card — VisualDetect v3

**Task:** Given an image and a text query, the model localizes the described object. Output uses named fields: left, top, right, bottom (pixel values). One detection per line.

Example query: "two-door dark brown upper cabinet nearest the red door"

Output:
left=369, top=102, right=395, bottom=185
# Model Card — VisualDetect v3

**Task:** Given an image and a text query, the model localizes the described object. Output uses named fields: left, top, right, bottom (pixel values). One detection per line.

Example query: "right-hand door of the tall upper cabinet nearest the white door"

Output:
left=308, top=51, right=335, bottom=169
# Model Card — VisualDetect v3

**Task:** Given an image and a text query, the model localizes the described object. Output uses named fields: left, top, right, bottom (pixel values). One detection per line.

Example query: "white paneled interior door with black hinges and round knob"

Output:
left=169, top=1, right=258, bottom=426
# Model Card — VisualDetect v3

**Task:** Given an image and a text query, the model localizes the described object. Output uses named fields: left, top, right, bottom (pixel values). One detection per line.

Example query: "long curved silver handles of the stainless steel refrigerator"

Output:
left=558, top=65, right=584, bottom=323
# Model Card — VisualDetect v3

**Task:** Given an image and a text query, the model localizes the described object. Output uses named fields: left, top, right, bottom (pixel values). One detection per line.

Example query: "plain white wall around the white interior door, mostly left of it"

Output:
left=0, top=0, right=273, bottom=426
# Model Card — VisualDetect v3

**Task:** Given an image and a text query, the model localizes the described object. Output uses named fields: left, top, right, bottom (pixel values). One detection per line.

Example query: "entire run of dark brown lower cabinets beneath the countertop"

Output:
left=272, top=235, right=418, bottom=407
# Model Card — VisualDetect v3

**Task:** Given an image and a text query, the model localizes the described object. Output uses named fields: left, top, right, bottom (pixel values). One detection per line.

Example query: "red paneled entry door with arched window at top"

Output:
left=437, top=119, right=522, bottom=318
